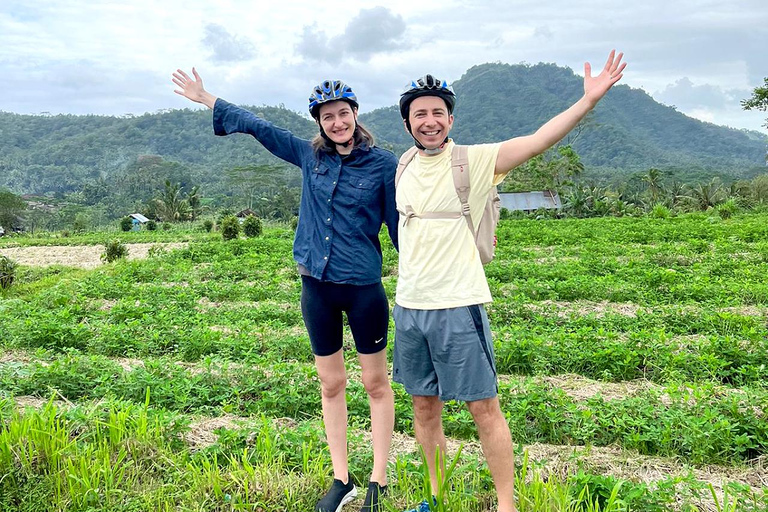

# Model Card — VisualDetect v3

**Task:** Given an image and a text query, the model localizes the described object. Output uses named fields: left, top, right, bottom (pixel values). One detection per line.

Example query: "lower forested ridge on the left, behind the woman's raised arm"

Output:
left=0, top=106, right=315, bottom=194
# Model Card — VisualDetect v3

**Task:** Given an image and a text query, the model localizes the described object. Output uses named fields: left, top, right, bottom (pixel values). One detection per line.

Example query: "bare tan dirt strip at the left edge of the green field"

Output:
left=0, top=242, right=187, bottom=269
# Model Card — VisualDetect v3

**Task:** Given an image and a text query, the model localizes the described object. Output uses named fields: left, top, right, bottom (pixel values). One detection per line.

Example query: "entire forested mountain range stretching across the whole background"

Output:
left=0, top=59, right=766, bottom=195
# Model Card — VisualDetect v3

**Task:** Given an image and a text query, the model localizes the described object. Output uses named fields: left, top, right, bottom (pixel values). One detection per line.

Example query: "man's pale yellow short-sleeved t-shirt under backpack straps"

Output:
left=395, top=141, right=504, bottom=309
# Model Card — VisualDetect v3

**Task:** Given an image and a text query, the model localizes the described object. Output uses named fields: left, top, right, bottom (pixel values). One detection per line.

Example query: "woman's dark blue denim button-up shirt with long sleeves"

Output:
left=213, top=98, right=398, bottom=285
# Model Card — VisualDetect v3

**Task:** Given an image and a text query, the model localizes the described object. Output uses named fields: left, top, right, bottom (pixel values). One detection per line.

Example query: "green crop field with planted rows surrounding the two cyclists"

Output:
left=0, top=214, right=768, bottom=511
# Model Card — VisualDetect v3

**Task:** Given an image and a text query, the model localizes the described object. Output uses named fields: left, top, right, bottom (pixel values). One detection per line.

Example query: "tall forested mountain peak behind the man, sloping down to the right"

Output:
left=363, top=63, right=768, bottom=184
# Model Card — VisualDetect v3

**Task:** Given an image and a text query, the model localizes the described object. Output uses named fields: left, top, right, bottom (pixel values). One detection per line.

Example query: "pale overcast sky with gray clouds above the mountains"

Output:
left=0, top=0, right=768, bottom=133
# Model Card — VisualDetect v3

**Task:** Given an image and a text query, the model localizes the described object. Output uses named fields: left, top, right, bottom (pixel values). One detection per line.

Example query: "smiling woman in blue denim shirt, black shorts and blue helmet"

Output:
left=173, top=68, right=398, bottom=512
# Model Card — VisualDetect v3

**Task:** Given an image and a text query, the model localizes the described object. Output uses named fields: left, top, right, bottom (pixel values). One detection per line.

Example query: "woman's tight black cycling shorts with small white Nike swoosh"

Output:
left=301, top=276, right=389, bottom=356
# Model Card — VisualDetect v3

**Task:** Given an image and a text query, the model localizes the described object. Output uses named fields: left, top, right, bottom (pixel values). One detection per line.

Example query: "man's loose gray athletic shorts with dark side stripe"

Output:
left=392, top=305, right=499, bottom=402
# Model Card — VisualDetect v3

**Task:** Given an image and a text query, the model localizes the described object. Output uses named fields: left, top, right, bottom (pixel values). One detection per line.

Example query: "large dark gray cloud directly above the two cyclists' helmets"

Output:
left=296, top=7, right=405, bottom=64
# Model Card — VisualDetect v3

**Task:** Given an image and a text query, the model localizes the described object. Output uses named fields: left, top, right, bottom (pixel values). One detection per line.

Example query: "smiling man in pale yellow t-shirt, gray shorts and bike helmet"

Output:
left=393, top=51, right=626, bottom=512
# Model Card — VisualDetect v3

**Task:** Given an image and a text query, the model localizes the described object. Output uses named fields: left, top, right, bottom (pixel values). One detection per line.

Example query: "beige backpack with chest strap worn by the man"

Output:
left=395, top=144, right=501, bottom=265
